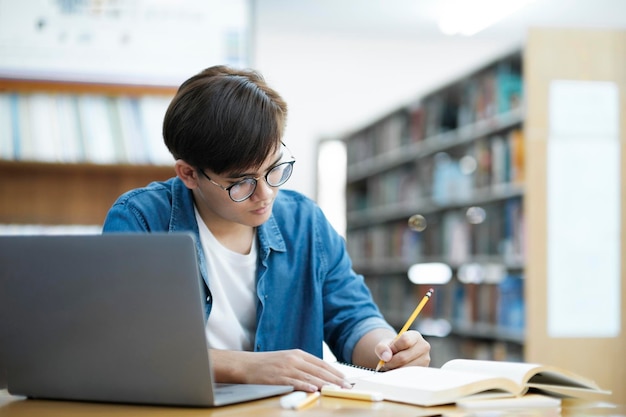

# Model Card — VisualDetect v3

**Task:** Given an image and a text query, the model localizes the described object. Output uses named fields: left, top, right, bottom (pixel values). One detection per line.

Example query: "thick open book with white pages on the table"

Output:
left=335, top=359, right=611, bottom=406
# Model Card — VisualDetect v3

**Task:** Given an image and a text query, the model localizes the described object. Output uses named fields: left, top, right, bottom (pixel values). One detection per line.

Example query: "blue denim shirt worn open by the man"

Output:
left=103, top=177, right=391, bottom=362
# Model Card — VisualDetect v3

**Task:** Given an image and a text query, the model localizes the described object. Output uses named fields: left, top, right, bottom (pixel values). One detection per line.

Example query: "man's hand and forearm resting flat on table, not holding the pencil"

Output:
left=211, top=349, right=351, bottom=392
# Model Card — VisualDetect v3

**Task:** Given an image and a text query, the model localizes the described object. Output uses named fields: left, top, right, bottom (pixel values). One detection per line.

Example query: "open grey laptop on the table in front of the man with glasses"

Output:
left=0, top=233, right=293, bottom=407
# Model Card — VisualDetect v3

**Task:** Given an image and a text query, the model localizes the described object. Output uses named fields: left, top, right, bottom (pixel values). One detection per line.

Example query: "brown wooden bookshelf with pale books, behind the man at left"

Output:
left=0, top=78, right=176, bottom=226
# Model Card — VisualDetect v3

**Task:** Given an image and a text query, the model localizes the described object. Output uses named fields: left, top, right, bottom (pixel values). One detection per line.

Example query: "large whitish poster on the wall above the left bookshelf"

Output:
left=0, top=0, right=252, bottom=85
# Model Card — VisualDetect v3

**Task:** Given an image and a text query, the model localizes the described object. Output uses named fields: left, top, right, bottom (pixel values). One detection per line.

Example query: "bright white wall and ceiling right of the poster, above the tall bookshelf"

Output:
left=253, top=0, right=626, bottom=202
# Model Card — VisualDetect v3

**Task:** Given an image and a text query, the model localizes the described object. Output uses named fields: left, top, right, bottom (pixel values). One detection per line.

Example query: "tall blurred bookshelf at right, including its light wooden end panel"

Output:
left=343, top=28, right=626, bottom=403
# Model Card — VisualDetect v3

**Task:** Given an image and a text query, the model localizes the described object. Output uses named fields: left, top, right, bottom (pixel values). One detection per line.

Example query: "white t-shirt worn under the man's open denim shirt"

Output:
left=195, top=209, right=257, bottom=351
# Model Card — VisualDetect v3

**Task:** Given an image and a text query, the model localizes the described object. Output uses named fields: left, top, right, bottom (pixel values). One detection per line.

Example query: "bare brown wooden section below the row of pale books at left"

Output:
left=0, top=161, right=175, bottom=225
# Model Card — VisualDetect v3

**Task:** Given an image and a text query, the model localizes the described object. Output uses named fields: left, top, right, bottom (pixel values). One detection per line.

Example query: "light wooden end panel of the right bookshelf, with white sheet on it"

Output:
left=524, top=29, right=626, bottom=403
